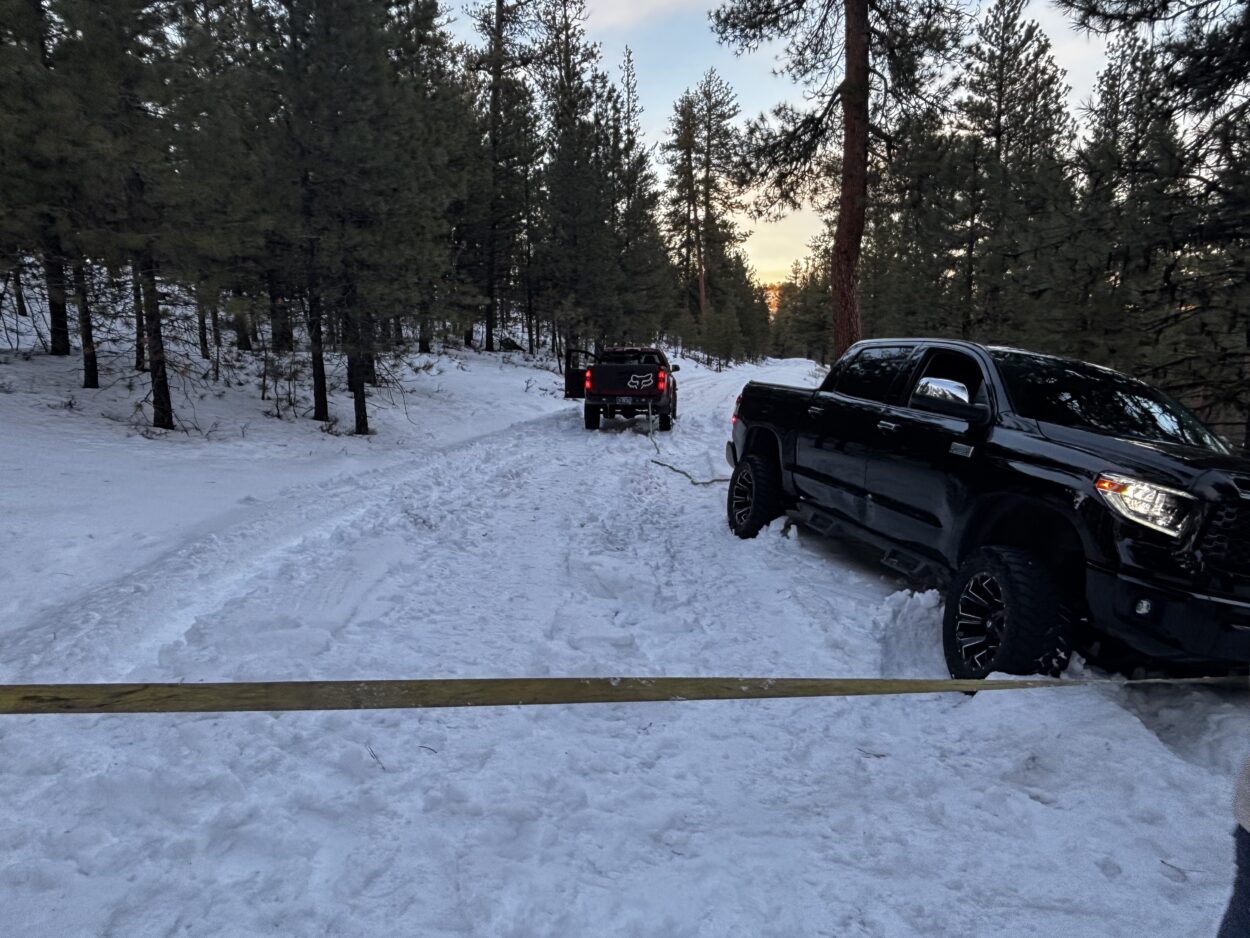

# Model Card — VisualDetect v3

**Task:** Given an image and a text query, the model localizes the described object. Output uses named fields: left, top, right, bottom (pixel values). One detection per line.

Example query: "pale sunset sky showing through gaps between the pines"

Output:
left=454, top=0, right=1105, bottom=283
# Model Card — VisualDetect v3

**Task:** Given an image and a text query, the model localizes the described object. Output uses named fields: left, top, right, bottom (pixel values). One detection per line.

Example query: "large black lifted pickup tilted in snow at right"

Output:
left=726, top=339, right=1250, bottom=678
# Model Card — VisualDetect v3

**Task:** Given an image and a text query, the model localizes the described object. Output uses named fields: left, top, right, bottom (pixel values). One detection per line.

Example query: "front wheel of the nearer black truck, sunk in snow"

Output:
left=943, top=547, right=1071, bottom=680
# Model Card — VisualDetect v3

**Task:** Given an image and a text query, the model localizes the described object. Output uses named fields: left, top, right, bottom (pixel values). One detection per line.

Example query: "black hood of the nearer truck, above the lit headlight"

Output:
left=1038, top=420, right=1250, bottom=490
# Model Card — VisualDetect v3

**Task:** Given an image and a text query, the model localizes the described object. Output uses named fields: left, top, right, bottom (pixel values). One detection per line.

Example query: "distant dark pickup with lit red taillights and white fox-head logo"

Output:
left=583, top=348, right=680, bottom=430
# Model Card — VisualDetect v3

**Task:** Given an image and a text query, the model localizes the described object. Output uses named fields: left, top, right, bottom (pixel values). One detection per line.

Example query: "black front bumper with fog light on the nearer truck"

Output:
left=1088, top=567, right=1250, bottom=665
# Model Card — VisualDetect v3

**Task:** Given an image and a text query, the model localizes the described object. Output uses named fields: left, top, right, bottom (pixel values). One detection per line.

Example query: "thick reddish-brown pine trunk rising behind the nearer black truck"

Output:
left=829, top=0, right=869, bottom=356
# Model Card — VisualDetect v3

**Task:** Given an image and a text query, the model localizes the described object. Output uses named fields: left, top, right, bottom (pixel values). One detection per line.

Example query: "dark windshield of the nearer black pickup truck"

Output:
left=990, top=349, right=1229, bottom=453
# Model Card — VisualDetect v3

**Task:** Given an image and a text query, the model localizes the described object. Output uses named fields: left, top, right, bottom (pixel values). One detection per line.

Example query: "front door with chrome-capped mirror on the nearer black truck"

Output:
left=866, top=348, right=990, bottom=558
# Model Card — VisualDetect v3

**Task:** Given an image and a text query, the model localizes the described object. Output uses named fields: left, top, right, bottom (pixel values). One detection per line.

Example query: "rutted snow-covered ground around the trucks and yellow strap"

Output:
left=0, top=342, right=1250, bottom=938
